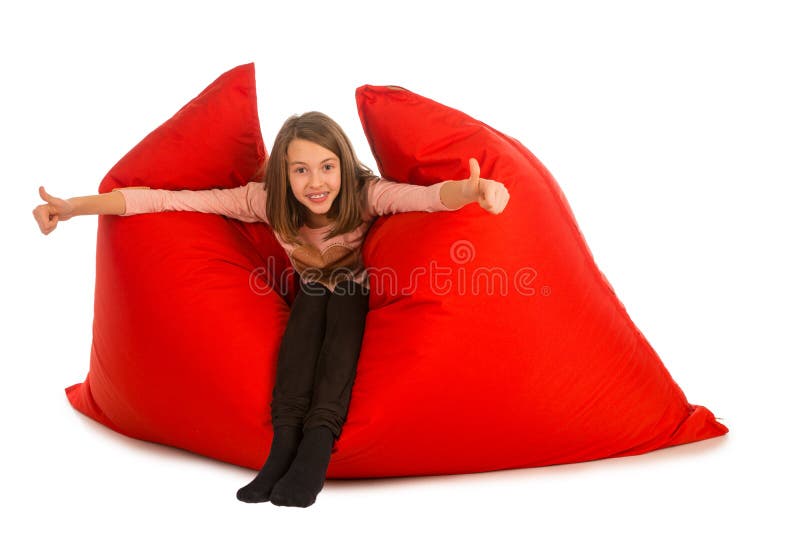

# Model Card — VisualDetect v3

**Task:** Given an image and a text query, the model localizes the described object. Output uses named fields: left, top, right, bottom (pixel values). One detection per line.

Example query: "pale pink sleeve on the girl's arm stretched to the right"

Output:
left=367, top=178, right=457, bottom=216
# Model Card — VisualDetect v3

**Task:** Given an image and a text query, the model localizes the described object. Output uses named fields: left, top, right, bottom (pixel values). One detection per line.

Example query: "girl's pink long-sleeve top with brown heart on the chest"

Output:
left=114, top=179, right=457, bottom=290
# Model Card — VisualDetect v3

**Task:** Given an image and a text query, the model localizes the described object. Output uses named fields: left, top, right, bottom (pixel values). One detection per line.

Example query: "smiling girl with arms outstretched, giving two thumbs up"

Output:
left=33, top=112, right=509, bottom=507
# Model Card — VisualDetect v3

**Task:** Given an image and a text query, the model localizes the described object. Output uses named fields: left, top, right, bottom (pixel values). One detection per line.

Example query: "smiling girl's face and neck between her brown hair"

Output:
left=286, top=139, right=342, bottom=226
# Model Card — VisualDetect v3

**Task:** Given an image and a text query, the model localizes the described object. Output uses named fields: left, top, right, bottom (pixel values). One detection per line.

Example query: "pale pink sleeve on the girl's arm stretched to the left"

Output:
left=114, top=182, right=269, bottom=224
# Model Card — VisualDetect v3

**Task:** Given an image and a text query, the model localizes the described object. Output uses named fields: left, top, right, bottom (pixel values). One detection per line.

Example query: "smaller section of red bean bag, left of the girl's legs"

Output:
left=67, top=63, right=292, bottom=472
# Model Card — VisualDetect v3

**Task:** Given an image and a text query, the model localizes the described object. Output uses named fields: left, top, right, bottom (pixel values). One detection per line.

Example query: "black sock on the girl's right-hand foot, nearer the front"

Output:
left=269, top=426, right=334, bottom=508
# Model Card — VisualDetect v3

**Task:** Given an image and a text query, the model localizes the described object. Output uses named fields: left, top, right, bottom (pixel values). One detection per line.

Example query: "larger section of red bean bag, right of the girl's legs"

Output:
left=338, top=85, right=728, bottom=476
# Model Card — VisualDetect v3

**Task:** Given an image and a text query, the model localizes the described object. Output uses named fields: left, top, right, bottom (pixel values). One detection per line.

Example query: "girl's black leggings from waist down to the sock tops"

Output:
left=271, top=280, right=369, bottom=439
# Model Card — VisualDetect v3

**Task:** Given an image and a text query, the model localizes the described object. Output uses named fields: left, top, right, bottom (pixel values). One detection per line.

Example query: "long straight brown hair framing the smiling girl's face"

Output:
left=264, top=111, right=378, bottom=248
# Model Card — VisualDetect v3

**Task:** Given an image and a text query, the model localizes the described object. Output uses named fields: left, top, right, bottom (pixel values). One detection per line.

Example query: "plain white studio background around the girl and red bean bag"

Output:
left=0, top=0, right=800, bottom=532
